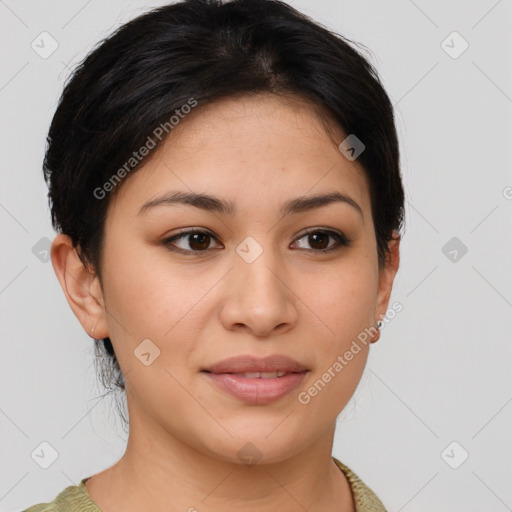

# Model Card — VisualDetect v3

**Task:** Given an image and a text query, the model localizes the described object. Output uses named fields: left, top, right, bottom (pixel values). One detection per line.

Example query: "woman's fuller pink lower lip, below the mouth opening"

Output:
left=203, top=372, right=307, bottom=405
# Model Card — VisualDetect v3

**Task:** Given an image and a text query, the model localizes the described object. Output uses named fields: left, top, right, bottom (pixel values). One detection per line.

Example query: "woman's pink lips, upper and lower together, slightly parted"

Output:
left=203, top=355, right=309, bottom=405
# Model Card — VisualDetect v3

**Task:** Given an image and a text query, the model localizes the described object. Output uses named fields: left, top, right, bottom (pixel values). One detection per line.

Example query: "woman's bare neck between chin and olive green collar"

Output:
left=87, top=412, right=355, bottom=512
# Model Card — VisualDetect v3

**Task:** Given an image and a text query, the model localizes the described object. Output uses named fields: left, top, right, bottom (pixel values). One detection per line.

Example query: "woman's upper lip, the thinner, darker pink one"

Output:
left=203, top=355, right=307, bottom=373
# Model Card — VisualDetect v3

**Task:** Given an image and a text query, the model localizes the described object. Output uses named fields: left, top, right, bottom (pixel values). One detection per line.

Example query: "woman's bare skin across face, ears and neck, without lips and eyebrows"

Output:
left=51, top=95, right=399, bottom=512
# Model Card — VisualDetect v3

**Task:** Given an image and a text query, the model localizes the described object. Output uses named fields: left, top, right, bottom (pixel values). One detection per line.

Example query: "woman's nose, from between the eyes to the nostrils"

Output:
left=220, top=242, right=298, bottom=337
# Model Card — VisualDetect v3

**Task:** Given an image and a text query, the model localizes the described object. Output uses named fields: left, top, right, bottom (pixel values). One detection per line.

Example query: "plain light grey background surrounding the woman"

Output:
left=0, top=0, right=512, bottom=512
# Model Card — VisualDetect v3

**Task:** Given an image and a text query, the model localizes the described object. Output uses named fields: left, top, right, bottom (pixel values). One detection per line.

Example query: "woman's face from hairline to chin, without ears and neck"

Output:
left=76, top=96, right=398, bottom=463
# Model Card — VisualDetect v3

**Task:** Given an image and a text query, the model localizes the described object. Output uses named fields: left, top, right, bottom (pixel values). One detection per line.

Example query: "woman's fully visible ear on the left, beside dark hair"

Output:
left=51, top=234, right=109, bottom=339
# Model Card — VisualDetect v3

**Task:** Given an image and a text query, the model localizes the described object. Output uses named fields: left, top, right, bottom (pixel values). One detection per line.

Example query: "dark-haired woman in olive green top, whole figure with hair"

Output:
left=28, top=0, right=404, bottom=512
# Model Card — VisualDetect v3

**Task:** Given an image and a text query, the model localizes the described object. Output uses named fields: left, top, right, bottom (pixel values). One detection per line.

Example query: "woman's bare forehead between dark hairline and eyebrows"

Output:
left=110, top=94, right=370, bottom=220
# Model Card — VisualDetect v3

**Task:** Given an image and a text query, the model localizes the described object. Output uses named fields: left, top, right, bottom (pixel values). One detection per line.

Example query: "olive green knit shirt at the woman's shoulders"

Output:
left=23, top=457, right=386, bottom=512
